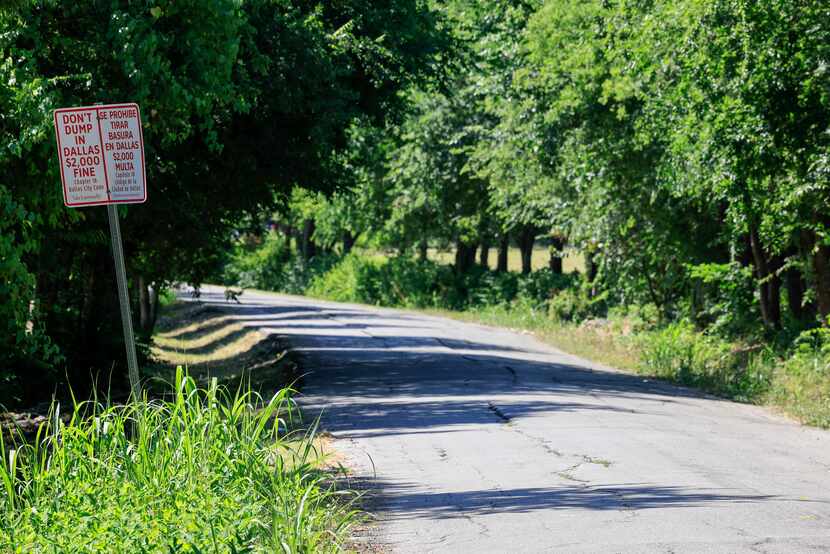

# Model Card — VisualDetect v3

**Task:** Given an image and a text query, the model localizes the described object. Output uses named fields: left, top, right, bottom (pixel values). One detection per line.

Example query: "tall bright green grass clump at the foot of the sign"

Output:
left=0, top=369, right=355, bottom=552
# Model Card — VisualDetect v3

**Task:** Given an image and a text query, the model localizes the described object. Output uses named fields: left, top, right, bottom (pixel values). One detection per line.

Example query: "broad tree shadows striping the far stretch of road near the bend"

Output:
left=193, top=292, right=740, bottom=438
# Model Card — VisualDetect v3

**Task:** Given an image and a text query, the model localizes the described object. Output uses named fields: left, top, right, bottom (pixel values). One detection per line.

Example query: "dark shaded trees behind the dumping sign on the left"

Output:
left=0, top=0, right=450, bottom=404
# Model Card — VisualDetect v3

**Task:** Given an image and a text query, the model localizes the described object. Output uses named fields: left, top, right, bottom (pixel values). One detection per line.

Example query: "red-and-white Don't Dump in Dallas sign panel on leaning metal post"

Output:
left=55, top=104, right=147, bottom=208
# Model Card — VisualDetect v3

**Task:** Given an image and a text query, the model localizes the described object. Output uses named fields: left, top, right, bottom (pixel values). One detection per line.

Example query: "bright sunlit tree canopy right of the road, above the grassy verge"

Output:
left=284, top=0, right=830, bottom=338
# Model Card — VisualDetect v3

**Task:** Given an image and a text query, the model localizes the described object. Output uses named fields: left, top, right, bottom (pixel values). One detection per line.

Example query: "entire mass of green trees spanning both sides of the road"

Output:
left=0, top=0, right=830, bottom=422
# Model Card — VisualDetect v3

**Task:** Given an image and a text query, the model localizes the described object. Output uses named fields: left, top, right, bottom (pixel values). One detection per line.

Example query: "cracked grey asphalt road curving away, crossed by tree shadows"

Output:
left=197, top=287, right=830, bottom=553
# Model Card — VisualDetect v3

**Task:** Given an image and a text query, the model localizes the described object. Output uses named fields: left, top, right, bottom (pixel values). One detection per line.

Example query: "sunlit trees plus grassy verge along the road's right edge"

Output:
left=217, top=0, right=830, bottom=432
